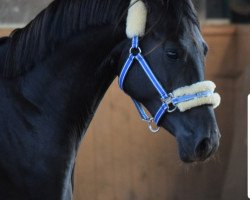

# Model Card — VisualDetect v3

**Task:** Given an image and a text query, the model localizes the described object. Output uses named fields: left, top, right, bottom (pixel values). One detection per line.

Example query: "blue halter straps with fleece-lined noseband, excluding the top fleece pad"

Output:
left=119, top=36, right=220, bottom=133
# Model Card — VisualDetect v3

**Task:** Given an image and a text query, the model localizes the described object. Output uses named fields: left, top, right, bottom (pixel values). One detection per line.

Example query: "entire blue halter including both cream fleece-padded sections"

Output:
left=119, top=0, right=220, bottom=133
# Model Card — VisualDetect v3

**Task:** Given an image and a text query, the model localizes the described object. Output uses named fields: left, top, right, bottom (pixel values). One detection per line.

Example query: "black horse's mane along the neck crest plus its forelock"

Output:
left=2, top=0, right=198, bottom=77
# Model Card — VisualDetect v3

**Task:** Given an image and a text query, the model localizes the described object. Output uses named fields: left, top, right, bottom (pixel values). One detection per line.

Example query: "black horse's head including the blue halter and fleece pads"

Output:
left=119, top=0, right=220, bottom=162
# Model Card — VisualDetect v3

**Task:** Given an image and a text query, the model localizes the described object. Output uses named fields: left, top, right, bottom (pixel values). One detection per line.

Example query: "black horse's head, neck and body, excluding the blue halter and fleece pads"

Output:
left=0, top=0, right=220, bottom=200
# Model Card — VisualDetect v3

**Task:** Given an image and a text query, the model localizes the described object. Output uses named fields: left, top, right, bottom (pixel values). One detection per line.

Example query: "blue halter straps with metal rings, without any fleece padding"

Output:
left=119, top=36, right=213, bottom=133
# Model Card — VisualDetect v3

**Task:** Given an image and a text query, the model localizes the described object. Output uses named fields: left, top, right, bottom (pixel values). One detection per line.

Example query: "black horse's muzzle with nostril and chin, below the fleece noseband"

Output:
left=161, top=107, right=221, bottom=163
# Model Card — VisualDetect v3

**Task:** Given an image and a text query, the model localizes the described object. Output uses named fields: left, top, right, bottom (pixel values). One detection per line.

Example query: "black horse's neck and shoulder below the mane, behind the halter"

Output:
left=0, top=26, right=122, bottom=199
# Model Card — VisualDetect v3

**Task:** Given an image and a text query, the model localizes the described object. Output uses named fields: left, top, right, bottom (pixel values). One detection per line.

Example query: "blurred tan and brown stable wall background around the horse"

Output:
left=0, top=0, right=250, bottom=200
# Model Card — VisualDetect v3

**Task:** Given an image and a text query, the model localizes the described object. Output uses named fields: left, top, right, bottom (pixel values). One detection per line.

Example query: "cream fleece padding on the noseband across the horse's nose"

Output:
left=173, top=81, right=221, bottom=112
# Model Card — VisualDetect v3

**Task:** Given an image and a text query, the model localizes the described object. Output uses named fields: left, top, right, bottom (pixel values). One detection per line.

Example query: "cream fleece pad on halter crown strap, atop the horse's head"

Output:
left=126, top=0, right=147, bottom=38
